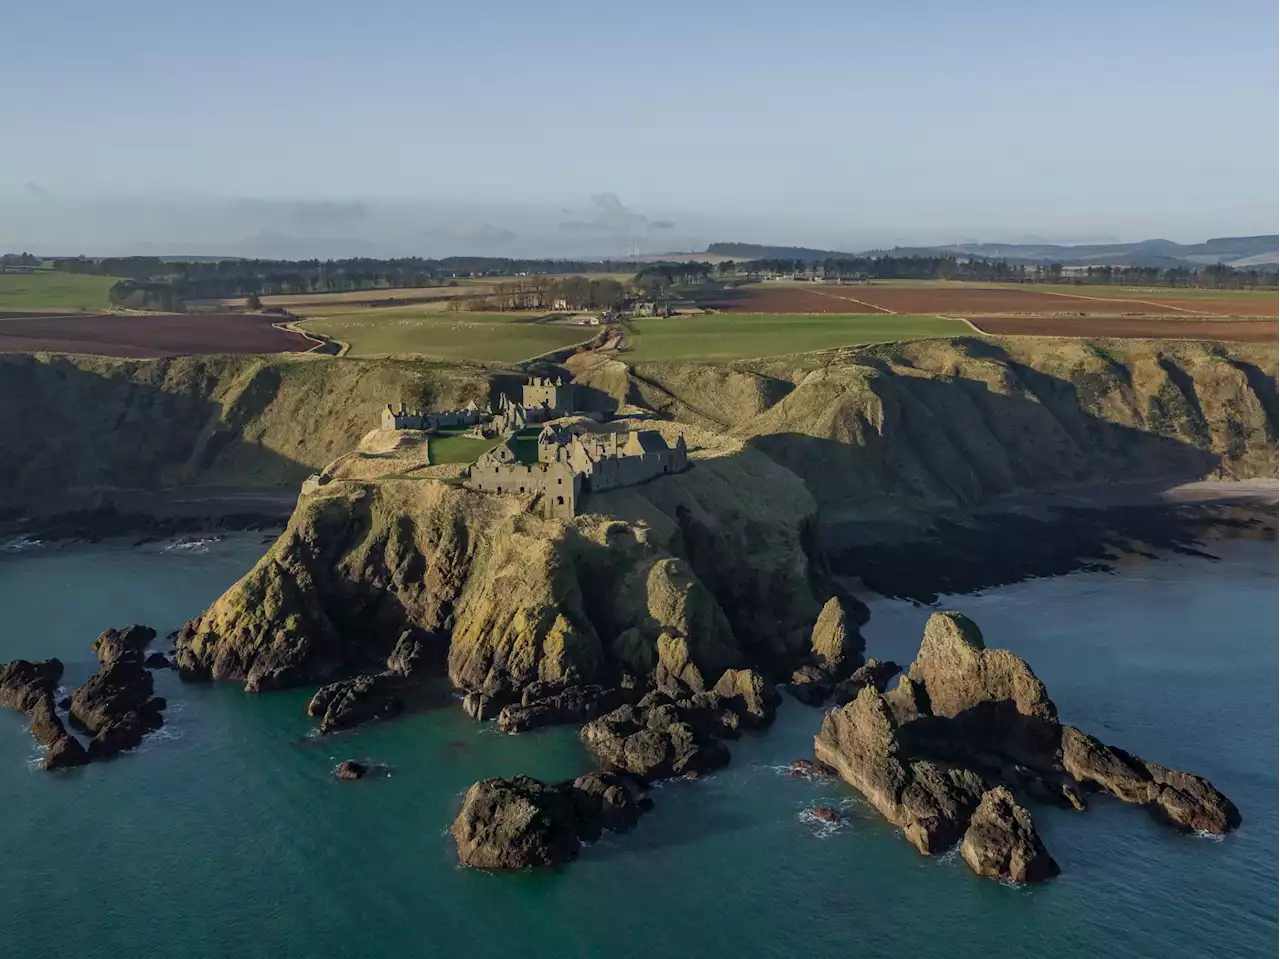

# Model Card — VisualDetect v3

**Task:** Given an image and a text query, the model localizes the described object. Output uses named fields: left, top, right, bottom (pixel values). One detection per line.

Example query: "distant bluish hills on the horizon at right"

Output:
left=707, top=233, right=1280, bottom=269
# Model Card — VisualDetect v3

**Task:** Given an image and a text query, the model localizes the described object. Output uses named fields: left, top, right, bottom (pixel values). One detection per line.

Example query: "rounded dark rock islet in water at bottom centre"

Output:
left=452, top=772, right=640, bottom=869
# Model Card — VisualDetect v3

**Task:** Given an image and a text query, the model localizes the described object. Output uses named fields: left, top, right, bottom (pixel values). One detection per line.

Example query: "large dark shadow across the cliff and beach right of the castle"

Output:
left=749, top=341, right=1244, bottom=603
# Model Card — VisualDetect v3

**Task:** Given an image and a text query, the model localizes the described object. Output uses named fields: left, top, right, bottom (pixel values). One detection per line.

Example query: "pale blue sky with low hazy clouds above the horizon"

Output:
left=0, top=0, right=1280, bottom=256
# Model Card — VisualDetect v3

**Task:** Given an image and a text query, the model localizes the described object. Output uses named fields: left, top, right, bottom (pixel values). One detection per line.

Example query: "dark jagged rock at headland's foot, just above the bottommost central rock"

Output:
left=581, top=704, right=728, bottom=782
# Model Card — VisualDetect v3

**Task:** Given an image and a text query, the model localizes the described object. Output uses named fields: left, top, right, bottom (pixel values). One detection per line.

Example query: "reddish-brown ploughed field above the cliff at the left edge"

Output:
left=0, top=312, right=316, bottom=359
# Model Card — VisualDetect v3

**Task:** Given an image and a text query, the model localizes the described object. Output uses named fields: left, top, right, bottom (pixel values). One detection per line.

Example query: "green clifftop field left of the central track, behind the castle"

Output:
left=303, top=307, right=596, bottom=362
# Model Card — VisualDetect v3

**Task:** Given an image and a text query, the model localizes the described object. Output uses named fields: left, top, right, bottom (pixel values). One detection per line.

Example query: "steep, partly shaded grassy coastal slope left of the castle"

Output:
left=0, top=355, right=489, bottom=510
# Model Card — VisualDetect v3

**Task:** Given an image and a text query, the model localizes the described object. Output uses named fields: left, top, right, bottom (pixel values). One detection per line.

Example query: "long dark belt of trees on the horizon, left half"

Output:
left=54, top=256, right=640, bottom=309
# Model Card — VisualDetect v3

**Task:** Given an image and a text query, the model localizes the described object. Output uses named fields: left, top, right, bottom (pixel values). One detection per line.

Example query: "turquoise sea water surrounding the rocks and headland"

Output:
left=0, top=535, right=1280, bottom=959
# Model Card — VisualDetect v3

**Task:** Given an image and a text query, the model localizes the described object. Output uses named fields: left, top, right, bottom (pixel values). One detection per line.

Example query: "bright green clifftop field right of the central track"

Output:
left=626, top=314, right=973, bottom=362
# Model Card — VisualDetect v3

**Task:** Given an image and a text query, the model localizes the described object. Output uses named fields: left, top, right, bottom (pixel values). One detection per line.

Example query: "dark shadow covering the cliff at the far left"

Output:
left=0, top=353, right=311, bottom=535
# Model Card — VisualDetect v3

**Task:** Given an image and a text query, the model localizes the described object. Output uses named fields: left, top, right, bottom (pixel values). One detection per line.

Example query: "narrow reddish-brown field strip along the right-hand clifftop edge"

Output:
left=970, top=316, right=1280, bottom=343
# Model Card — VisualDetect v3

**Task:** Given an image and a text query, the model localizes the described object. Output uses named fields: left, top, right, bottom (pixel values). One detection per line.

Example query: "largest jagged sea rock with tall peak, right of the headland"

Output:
left=814, top=613, right=1240, bottom=881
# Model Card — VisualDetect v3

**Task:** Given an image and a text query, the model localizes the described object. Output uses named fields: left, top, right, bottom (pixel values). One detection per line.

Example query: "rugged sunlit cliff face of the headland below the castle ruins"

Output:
left=178, top=451, right=824, bottom=693
